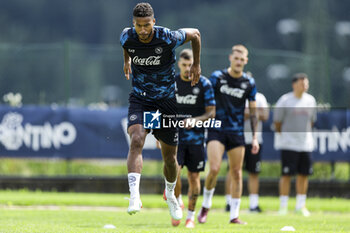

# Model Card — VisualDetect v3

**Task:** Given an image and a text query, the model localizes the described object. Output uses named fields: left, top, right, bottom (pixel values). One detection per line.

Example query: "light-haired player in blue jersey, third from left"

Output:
left=198, top=45, right=259, bottom=224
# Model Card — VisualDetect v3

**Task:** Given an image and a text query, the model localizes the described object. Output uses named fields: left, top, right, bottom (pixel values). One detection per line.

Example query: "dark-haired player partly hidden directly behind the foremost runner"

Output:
left=172, top=49, right=215, bottom=228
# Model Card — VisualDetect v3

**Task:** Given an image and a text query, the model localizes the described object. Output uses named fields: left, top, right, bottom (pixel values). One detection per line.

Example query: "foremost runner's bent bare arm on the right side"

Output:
left=182, top=28, right=201, bottom=86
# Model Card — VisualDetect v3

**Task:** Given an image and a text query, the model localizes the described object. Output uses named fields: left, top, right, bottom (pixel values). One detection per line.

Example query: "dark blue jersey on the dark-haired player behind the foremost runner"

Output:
left=175, top=75, right=215, bottom=145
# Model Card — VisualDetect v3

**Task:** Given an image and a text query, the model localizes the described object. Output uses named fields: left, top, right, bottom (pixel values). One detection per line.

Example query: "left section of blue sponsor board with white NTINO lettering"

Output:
left=0, top=106, right=161, bottom=159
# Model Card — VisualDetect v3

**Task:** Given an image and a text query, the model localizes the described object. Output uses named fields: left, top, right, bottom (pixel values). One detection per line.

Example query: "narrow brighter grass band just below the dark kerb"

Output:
left=0, top=190, right=350, bottom=213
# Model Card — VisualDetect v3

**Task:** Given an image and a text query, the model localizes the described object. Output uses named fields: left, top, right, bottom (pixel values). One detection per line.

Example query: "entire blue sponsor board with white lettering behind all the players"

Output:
left=0, top=105, right=350, bottom=161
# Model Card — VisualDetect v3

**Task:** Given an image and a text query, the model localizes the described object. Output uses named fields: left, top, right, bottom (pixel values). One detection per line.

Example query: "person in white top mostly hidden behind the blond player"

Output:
left=225, top=80, right=270, bottom=213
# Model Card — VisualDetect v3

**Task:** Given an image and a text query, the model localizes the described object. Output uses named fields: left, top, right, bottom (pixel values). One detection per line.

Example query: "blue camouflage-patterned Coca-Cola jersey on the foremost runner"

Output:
left=120, top=26, right=186, bottom=101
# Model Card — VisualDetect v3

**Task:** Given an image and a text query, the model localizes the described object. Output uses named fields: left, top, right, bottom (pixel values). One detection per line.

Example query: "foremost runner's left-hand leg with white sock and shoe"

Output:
left=127, top=124, right=147, bottom=214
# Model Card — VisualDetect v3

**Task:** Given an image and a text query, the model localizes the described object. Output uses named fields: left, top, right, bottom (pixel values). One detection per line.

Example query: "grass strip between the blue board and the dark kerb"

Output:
left=0, top=158, right=350, bottom=180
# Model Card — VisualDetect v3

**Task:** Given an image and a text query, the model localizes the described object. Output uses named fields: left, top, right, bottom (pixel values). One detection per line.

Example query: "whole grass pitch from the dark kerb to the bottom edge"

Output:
left=0, top=190, right=350, bottom=233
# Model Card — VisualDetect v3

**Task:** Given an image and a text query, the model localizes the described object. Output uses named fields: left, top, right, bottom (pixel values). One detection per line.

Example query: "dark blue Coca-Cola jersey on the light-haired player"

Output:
left=209, top=69, right=257, bottom=135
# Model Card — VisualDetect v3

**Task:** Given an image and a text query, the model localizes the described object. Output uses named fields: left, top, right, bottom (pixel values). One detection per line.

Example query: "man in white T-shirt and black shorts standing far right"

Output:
left=274, top=73, right=317, bottom=216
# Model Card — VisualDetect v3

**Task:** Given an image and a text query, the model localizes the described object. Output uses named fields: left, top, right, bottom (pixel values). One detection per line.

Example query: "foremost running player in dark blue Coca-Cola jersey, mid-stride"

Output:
left=120, top=3, right=201, bottom=220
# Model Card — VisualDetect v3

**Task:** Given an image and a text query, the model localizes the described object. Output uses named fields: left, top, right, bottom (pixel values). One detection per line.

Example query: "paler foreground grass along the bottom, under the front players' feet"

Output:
left=0, top=209, right=350, bottom=233
